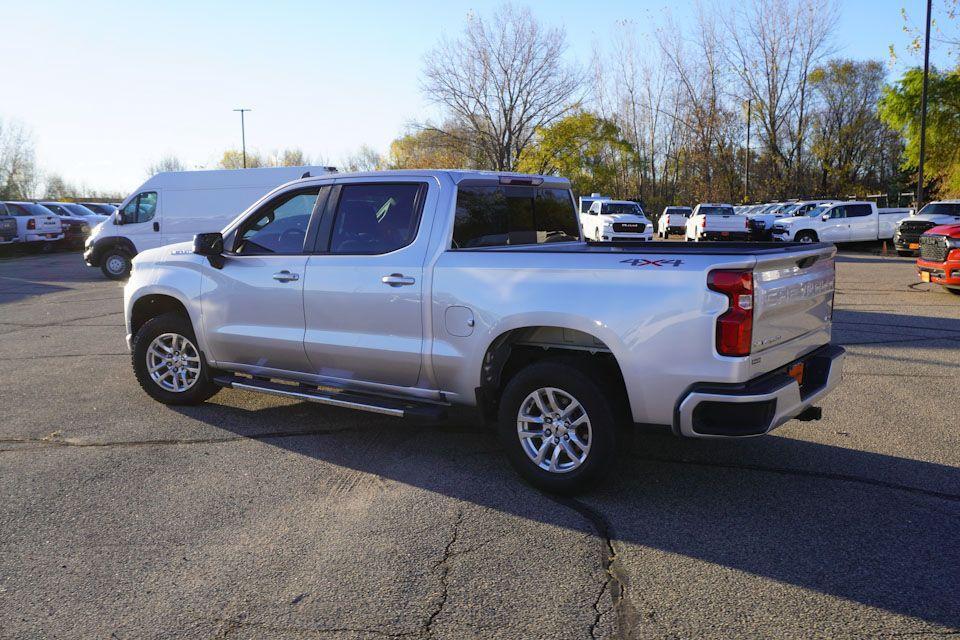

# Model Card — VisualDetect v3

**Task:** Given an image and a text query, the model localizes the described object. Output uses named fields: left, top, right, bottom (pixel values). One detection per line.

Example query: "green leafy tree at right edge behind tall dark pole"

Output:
left=880, top=68, right=960, bottom=196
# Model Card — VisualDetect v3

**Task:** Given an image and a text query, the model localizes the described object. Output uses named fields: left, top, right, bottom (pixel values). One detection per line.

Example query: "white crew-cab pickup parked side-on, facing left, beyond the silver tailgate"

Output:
left=771, top=201, right=910, bottom=243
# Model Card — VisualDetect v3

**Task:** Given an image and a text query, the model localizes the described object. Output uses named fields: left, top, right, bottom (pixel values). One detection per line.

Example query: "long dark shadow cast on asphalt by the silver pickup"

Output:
left=177, top=400, right=960, bottom=633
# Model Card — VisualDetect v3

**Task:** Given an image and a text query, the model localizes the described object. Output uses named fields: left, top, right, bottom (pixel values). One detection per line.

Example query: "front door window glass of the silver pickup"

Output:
left=234, top=187, right=320, bottom=255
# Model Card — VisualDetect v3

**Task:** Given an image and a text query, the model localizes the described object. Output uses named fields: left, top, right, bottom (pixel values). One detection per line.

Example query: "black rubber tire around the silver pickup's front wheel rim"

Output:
left=132, top=313, right=220, bottom=405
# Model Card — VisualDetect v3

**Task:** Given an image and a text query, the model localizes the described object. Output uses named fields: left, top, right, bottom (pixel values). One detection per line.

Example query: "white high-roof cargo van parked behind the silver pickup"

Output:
left=83, top=166, right=335, bottom=280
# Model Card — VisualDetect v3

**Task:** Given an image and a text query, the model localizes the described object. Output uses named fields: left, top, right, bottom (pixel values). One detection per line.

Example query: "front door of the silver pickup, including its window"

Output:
left=201, top=187, right=320, bottom=374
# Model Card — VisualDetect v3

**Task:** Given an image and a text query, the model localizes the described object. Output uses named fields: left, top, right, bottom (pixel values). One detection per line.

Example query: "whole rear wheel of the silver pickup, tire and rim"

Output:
left=498, top=360, right=621, bottom=493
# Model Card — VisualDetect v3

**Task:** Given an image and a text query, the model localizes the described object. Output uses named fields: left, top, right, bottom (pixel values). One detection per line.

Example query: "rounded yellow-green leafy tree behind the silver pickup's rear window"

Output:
left=517, top=111, right=639, bottom=197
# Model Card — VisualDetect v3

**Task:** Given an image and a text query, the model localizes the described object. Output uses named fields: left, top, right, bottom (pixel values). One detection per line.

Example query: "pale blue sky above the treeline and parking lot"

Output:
left=0, top=0, right=946, bottom=191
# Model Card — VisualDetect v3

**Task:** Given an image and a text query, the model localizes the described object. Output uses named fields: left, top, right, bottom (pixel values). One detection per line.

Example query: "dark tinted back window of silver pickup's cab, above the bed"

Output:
left=452, top=185, right=580, bottom=249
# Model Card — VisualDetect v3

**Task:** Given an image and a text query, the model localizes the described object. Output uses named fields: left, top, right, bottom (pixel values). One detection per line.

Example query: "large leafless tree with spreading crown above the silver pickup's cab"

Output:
left=422, top=5, right=585, bottom=170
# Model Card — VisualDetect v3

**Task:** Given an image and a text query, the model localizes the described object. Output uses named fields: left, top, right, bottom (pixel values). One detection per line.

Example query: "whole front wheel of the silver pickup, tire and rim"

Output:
left=133, top=313, right=220, bottom=405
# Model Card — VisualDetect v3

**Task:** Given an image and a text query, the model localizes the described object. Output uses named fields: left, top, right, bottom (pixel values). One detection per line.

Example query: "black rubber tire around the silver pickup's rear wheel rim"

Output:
left=498, top=360, right=629, bottom=493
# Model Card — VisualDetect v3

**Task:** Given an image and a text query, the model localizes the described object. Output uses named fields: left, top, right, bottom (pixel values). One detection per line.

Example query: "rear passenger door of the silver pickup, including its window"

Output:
left=303, top=179, right=436, bottom=387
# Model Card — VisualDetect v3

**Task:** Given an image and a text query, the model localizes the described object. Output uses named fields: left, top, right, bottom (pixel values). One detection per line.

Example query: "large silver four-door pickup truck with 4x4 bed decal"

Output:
left=125, top=171, right=843, bottom=491
